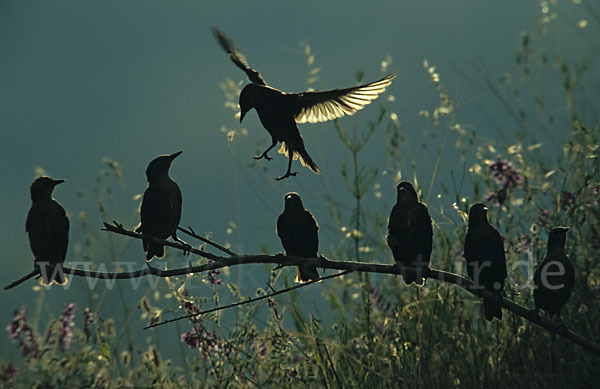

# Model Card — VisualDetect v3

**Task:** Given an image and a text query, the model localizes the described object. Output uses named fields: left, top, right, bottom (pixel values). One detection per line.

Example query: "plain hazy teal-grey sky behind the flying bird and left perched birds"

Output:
left=0, top=0, right=598, bottom=360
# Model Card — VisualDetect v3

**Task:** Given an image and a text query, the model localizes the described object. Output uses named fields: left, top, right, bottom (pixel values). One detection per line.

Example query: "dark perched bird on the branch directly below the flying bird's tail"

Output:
left=277, top=192, right=320, bottom=283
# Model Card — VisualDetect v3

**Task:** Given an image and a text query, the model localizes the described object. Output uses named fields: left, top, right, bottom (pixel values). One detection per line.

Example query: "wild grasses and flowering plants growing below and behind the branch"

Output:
left=0, top=5, right=600, bottom=387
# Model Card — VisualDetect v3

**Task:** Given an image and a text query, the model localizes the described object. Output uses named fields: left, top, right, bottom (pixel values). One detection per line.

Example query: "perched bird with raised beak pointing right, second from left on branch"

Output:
left=135, top=151, right=189, bottom=262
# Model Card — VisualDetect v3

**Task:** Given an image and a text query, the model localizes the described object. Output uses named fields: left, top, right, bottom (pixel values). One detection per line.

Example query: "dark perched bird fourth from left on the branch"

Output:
left=386, top=181, right=433, bottom=285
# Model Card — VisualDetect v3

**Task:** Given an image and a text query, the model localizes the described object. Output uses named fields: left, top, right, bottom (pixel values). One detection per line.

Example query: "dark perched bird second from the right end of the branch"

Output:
left=464, top=203, right=506, bottom=321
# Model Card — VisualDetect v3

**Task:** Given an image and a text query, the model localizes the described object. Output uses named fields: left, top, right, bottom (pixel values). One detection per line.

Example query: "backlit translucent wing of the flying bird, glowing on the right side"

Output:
left=294, top=74, right=396, bottom=123
